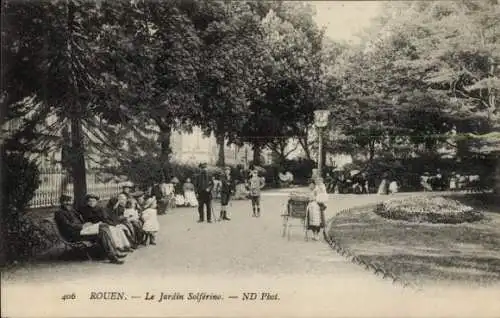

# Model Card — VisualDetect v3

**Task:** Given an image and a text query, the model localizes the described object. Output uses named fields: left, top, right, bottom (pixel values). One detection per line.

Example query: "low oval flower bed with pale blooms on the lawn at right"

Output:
left=374, top=196, right=484, bottom=224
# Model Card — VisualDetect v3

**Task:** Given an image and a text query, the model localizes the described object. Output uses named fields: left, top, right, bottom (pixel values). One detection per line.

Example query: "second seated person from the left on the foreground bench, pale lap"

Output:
left=80, top=194, right=131, bottom=251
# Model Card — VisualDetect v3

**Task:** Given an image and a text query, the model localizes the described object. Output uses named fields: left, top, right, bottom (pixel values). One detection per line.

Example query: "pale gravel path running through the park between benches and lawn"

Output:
left=0, top=191, right=414, bottom=282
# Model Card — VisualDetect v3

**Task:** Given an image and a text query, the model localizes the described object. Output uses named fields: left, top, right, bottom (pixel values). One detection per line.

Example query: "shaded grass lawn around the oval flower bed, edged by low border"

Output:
left=330, top=195, right=500, bottom=285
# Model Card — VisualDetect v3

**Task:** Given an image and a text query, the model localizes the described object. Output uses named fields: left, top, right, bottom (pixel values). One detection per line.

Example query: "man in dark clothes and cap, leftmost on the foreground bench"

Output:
left=55, top=195, right=125, bottom=264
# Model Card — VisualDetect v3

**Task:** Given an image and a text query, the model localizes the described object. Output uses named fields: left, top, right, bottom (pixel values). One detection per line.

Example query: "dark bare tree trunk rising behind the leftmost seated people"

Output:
left=71, top=114, right=87, bottom=205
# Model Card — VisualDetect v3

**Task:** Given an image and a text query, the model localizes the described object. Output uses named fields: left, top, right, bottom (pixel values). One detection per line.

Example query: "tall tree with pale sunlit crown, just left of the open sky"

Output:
left=236, top=3, right=334, bottom=162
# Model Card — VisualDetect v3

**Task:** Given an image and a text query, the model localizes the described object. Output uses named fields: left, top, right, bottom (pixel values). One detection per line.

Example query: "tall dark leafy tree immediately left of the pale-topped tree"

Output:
left=195, top=2, right=268, bottom=166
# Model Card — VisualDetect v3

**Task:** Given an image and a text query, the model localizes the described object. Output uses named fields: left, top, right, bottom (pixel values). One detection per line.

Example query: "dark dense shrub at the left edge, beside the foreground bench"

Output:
left=2, top=151, right=50, bottom=261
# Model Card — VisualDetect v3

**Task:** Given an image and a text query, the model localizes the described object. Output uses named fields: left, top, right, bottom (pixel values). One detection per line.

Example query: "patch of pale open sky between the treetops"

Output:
left=310, top=1, right=382, bottom=41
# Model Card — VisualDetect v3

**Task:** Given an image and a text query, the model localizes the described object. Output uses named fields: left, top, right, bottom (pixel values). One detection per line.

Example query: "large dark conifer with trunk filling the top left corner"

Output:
left=2, top=1, right=131, bottom=199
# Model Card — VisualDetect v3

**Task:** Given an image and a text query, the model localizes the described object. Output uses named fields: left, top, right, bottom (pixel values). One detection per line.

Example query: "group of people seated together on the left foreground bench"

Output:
left=55, top=187, right=160, bottom=264
